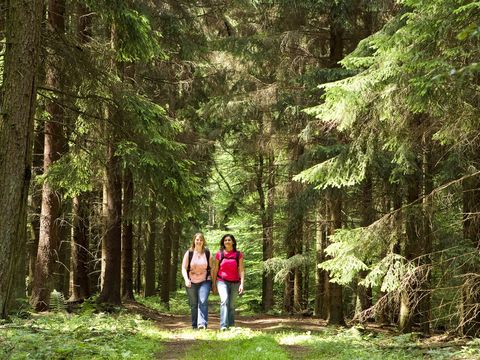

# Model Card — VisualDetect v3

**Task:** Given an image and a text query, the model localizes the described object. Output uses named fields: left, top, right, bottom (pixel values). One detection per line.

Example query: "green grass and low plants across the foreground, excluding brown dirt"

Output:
left=0, top=294, right=480, bottom=360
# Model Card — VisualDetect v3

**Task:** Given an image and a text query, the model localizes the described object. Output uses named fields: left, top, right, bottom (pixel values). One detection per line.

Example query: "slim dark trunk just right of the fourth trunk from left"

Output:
left=122, top=169, right=134, bottom=300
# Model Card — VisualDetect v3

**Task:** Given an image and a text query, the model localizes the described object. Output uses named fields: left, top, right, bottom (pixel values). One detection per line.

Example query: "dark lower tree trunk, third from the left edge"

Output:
left=70, top=194, right=90, bottom=302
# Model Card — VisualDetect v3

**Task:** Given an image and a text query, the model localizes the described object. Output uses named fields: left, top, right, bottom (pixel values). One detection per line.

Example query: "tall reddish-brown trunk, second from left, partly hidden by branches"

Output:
left=30, top=0, right=66, bottom=311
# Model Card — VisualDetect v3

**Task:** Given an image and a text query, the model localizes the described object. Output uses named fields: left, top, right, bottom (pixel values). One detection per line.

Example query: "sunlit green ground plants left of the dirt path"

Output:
left=0, top=313, right=162, bottom=359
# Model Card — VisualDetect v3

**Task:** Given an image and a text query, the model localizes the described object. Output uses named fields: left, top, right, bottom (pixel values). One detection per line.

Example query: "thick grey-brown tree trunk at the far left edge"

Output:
left=0, top=0, right=43, bottom=317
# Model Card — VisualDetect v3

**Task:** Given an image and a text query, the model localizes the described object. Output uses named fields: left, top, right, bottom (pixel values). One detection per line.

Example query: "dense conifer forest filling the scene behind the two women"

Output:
left=0, top=0, right=480, bottom=342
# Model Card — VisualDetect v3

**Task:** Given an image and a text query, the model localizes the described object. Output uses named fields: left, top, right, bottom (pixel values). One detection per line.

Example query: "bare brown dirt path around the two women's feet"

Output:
left=124, top=302, right=325, bottom=360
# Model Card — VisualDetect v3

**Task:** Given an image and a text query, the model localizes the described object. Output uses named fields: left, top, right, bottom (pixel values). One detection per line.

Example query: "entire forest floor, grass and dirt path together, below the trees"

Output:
left=0, top=298, right=480, bottom=360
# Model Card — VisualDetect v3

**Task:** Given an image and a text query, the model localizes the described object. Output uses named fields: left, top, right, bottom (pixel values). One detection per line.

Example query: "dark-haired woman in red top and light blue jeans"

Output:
left=212, top=234, right=245, bottom=330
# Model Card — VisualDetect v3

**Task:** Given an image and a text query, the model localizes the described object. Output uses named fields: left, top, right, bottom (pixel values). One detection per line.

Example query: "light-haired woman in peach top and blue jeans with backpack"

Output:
left=182, top=233, right=212, bottom=329
